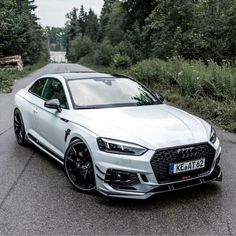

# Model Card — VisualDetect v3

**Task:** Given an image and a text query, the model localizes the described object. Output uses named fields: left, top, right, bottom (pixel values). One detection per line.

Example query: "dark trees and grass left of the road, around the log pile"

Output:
left=0, top=0, right=49, bottom=92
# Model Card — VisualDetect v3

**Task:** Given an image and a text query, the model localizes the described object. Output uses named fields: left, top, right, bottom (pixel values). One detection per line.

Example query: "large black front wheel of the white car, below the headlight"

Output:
left=64, top=140, right=96, bottom=193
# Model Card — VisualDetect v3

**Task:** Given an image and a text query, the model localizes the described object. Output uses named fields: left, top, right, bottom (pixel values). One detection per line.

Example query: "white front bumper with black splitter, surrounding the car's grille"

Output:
left=94, top=140, right=222, bottom=199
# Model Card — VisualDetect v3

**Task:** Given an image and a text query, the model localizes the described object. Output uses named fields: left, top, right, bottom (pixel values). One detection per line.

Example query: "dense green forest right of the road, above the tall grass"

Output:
left=65, top=0, right=236, bottom=67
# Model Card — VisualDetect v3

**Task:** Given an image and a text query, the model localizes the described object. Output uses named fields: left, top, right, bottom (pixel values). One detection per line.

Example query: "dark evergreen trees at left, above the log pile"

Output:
left=0, top=0, right=48, bottom=64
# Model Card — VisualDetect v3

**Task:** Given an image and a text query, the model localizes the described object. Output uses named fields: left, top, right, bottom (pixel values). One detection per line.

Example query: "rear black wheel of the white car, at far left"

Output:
left=14, top=109, right=28, bottom=146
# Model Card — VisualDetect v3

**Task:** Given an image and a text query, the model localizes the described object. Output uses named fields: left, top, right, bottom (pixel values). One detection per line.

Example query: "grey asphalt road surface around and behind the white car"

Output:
left=0, top=64, right=236, bottom=235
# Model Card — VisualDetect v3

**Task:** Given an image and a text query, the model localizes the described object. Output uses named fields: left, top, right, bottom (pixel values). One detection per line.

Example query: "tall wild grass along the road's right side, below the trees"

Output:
left=80, top=58, right=236, bottom=132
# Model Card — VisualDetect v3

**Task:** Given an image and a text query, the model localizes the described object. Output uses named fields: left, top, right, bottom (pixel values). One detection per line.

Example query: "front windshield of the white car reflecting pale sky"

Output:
left=68, top=78, right=161, bottom=108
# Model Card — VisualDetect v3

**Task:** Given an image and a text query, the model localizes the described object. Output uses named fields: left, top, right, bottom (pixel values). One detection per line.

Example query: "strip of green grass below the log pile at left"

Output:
left=0, top=62, right=45, bottom=93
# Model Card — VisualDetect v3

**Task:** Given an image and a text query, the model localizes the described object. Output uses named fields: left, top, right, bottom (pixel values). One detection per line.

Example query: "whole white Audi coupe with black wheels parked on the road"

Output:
left=14, top=72, right=222, bottom=199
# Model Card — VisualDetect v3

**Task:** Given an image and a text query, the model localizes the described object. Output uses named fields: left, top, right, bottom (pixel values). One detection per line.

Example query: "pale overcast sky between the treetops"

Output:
left=35, top=0, right=103, bottom=27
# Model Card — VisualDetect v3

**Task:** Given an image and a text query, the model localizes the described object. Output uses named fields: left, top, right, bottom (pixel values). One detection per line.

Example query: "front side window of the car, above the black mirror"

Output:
left=41, top=79, right=68, bottom=109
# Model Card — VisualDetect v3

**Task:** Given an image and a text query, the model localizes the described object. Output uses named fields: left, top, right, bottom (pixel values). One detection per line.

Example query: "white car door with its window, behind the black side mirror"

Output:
left=32, top=78, right=69, bottom=156
